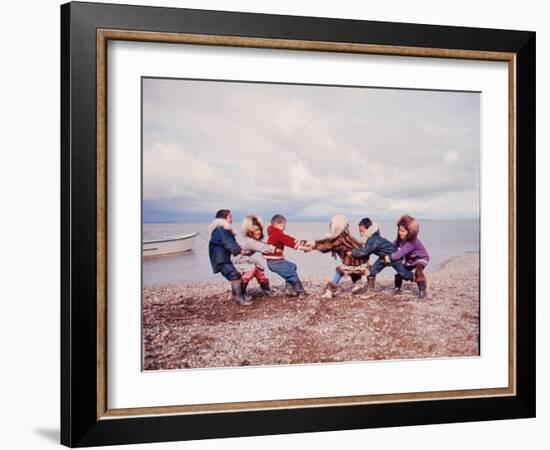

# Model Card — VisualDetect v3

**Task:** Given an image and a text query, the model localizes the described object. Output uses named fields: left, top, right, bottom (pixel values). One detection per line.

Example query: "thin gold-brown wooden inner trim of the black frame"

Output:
left=96, top=28, right=517, bottom=420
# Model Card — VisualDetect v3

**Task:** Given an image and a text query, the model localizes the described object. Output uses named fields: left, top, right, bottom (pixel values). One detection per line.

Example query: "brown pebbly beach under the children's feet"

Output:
left=143, top=253, right=479, bottom=370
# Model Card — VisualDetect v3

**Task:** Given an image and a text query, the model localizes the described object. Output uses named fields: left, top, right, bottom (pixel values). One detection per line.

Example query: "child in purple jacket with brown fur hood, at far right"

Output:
left=386, top=214, right=430, bottom=301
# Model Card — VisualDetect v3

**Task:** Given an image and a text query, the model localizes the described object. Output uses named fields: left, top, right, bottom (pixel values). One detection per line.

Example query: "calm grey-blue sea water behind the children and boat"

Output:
left=143, top=220, right=479, bottom=286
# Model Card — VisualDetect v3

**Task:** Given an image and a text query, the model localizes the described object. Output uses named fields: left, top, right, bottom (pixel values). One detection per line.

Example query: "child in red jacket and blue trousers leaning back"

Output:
left=264, top=214, right=311, bottom=297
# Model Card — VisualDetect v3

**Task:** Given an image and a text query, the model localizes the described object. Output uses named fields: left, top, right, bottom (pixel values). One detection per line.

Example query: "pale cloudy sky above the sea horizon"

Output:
left=143, top=78, right=480, bottom=222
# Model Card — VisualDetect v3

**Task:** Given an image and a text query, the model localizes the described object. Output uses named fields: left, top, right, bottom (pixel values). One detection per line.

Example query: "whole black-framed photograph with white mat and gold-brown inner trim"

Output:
left=61, top=2, right=536, bottom=447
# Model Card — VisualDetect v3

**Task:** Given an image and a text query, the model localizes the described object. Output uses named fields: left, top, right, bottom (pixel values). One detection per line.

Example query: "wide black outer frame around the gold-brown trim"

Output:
left=60, top=2, right=536, bottom=447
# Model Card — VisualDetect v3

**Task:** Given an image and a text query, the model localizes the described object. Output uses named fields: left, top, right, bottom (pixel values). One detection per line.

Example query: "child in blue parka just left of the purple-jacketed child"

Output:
left=349, top=217, right=410, bottom=290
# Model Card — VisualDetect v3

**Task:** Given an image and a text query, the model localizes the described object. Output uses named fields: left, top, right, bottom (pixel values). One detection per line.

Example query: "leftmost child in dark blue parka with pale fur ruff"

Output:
left=208, top=209, right=252, bottom=306
